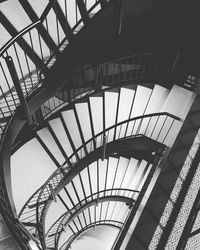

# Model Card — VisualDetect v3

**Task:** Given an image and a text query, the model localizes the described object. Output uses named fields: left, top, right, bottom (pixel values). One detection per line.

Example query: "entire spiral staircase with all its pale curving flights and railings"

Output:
left=0, top=0, right=200, bottom=250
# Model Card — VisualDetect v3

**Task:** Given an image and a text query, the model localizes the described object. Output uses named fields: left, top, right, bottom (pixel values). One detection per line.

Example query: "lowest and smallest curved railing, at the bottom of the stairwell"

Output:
left=59, top=220, right=123, bottom=250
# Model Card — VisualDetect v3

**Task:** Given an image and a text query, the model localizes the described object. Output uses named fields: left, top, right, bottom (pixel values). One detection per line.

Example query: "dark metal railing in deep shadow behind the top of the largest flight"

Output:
left=71, top=51, right=179, bottom=89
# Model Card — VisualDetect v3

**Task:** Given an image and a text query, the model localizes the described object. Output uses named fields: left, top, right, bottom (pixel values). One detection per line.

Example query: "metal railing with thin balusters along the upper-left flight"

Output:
left=0, top=0, right=106, bottom=141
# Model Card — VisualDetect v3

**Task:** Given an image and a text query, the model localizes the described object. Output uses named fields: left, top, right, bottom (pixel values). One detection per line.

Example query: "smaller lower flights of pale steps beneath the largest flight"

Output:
left=46, top=156, right=148, bottom=249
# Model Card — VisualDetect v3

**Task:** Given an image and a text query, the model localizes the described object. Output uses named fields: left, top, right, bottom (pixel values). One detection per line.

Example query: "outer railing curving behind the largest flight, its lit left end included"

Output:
left=36, top=51, right=178, bottom=123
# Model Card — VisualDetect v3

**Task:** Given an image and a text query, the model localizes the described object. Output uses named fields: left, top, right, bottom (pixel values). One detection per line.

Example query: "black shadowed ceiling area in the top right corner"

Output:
left=91, top=0, right=200, bottom=77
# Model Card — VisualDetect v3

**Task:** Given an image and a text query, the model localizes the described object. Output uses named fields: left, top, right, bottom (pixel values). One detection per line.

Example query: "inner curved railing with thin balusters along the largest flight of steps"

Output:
left=17, top=112, right=182, bottom=247
